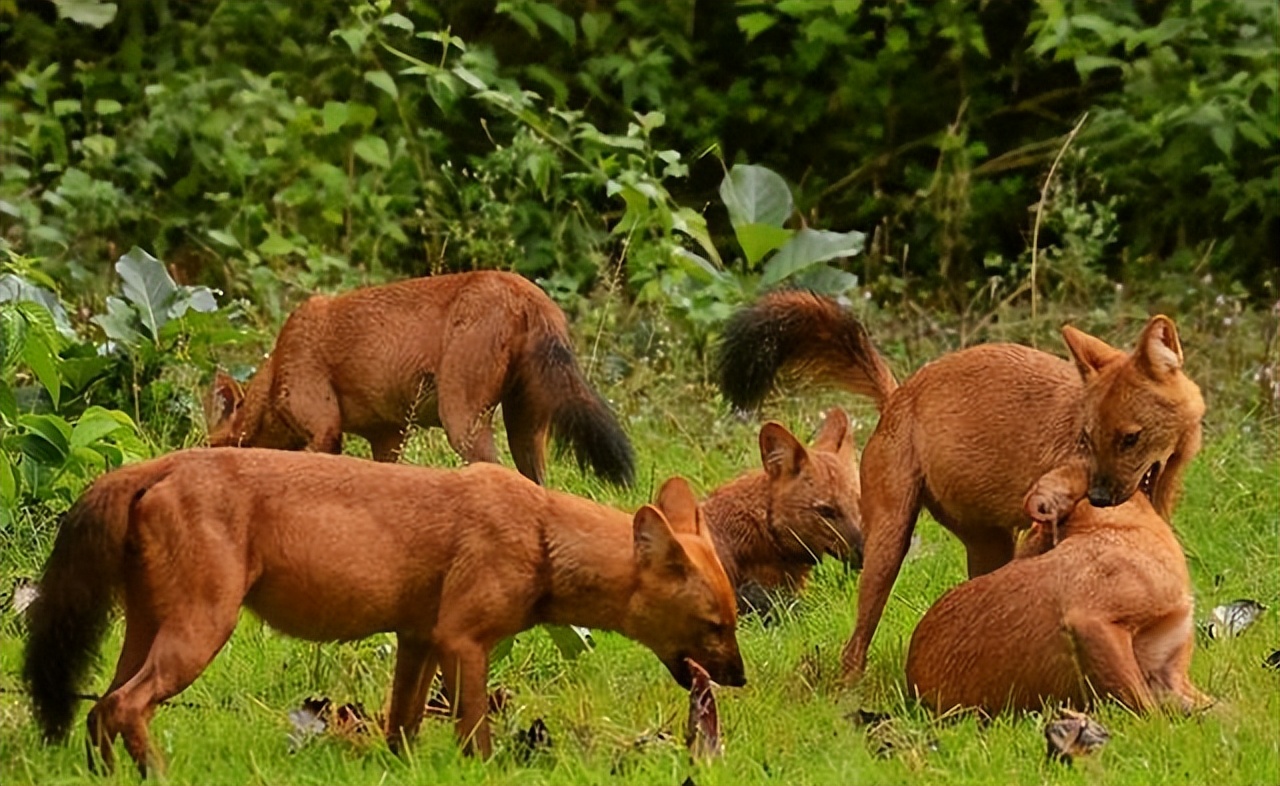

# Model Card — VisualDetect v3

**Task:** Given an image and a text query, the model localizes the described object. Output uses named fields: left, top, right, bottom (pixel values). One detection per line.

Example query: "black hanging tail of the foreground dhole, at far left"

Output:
left=22, top=475, right=141, bottom=741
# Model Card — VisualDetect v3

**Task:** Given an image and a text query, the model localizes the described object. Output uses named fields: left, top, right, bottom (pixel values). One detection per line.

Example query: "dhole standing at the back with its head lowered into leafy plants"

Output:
left=209, top=270, right=635, bottom=484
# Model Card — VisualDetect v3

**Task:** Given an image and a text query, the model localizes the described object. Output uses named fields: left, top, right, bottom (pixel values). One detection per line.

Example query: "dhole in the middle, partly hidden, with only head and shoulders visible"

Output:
left=703, top=407, right=863, bottom=597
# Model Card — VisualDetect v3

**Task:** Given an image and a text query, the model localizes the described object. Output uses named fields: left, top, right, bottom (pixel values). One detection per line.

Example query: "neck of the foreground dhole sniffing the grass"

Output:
left=535, top=493, right=639, bottom=634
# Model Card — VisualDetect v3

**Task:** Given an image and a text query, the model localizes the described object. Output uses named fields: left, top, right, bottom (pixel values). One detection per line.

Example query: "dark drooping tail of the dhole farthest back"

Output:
left=521, top=333, right=635, bottom=485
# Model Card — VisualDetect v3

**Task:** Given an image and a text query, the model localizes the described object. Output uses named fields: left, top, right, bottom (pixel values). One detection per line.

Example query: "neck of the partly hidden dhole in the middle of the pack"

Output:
left=703, top=470, right=787, bottom=588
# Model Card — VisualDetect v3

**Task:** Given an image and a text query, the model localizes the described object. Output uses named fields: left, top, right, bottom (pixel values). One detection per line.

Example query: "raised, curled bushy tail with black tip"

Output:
left=717, top=291, right=897, bottom=410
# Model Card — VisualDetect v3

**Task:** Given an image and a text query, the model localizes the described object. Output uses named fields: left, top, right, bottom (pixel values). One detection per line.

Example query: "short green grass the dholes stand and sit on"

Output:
left=0, top=312, right=1280, bottom=786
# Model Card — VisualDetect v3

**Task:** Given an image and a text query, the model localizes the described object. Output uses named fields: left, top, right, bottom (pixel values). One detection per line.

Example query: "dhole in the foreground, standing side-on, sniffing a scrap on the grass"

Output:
left=23, top=448, right=745, bottom=773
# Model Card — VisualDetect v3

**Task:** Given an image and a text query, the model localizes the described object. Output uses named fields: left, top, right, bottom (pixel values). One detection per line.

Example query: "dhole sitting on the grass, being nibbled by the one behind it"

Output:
left=906, top=475, right=1211, bottom=713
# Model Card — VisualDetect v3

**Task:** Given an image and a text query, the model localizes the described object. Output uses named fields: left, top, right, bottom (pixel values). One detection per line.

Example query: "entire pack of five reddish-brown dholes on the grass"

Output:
left=24, top=271, right=1211, bottom=774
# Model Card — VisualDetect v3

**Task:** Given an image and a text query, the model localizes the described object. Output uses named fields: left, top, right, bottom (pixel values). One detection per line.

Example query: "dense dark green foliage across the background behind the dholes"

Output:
left=0, top=0, right=1280, bottom=316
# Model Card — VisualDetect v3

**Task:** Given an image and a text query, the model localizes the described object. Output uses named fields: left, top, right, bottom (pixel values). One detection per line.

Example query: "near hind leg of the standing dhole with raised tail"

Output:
left=842, top=427, right=923, bottom=680
